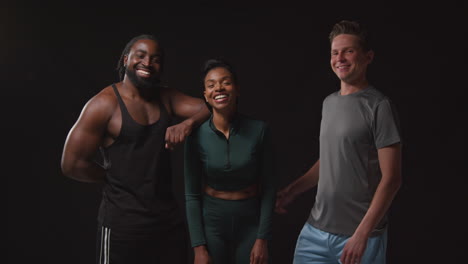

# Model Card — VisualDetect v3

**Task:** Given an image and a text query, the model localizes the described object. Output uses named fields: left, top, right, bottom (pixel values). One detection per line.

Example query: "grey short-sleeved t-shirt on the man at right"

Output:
left=308, top=87, right=401, bottom=235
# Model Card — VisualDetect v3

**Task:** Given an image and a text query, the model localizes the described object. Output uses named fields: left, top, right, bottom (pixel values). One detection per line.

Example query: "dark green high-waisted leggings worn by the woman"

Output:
left=203, top=195, right=266, bottom=264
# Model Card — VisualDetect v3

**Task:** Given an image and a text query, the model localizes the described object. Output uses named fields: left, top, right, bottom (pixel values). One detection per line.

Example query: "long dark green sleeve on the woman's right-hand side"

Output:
left=257, top=125, right=277, bottom=240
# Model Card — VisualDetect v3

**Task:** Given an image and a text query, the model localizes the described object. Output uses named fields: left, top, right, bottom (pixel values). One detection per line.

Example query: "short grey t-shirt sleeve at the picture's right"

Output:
left=373, top=99, right=402, bottom=149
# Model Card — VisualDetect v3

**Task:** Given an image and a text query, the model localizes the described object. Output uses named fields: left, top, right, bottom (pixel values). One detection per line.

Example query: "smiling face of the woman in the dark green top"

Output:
left=203, top=67, right=239, bottom=112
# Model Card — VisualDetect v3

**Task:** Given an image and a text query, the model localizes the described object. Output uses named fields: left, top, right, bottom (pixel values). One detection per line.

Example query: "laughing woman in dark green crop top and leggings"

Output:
left=184, top=60, right=276, bottom=263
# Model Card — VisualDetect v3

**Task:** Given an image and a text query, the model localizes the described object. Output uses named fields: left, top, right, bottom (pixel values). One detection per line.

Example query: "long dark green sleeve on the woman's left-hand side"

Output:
left=184, top=134, right=206, bottom=247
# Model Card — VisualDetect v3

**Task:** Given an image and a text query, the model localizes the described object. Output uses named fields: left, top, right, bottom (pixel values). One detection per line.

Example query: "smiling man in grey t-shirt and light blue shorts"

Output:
left=276, top=21, right=401, bottom=264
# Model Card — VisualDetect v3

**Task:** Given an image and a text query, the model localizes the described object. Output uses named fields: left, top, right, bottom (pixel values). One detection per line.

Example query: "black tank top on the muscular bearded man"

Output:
left=98, top=84, right=180, bottom=229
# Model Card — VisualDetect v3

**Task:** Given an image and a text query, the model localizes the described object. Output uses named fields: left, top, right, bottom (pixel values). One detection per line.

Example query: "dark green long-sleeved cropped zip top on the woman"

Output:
left=184, top=114, right=276, bottom=247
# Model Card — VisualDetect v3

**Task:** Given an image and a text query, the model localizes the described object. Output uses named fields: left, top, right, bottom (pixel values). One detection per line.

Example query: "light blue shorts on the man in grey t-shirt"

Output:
left=293, top=223, right=387, bottom=264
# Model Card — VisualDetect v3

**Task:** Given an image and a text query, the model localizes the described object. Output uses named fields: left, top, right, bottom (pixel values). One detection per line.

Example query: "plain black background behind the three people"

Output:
left=4, top=1, right=468, bottom=264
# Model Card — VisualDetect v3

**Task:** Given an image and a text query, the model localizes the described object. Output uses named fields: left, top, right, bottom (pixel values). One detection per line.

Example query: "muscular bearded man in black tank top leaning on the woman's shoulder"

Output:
left=61, top=35, right=209, bottom=264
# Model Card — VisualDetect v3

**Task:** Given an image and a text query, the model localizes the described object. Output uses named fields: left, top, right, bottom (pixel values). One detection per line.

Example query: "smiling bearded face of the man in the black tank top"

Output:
left=124, top=39, right=161, bottom=87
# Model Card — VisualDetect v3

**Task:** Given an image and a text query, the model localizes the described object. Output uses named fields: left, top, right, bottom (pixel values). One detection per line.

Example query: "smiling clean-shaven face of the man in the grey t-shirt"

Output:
left=330, top=34, right=374, bottom=84
